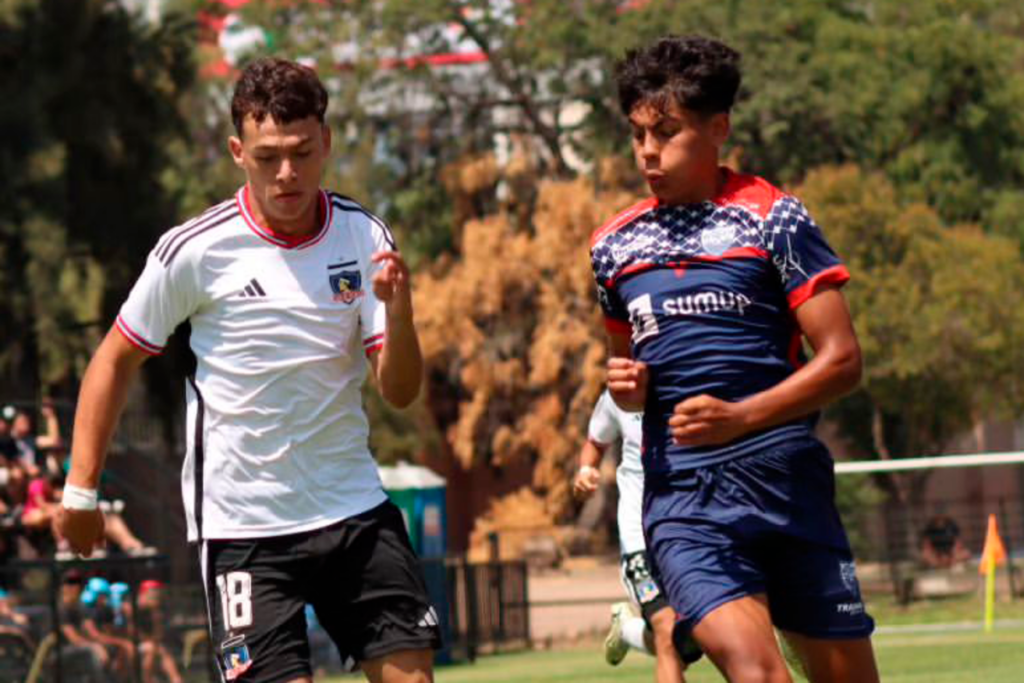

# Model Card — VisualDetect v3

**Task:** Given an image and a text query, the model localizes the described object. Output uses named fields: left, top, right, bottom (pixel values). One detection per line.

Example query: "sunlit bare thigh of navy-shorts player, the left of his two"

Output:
left=692, top=594, right=792, bottom=683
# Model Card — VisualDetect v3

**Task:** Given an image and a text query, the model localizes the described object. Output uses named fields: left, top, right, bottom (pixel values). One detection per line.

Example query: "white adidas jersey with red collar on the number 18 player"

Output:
left=117, top=187, right=395, bottom=541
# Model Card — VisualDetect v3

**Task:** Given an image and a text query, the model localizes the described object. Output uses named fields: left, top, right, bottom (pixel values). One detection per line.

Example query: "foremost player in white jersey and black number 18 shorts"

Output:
left=60, top=58, right=439, bottom=683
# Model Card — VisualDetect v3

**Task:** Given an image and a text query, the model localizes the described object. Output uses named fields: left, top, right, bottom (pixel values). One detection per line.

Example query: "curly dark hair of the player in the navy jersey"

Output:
left=615, top=36, right=740, bottom=116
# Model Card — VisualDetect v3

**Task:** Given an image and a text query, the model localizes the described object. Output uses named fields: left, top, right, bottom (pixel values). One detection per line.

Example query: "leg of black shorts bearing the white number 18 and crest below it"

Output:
left=204, top=538, right=311, bottom=683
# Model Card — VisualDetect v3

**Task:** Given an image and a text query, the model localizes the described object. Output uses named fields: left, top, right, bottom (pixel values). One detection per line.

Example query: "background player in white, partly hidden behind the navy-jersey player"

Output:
left=572, top=391, right=701, bottom=683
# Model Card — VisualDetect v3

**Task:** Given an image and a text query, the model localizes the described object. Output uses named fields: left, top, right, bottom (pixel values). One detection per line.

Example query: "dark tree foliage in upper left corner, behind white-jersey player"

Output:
left=0, top=0, right=193, bottom=384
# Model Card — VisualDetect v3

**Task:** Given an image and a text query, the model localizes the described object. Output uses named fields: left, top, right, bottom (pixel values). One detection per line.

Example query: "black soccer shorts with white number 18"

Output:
left=202, top=502, right=440, bottom=683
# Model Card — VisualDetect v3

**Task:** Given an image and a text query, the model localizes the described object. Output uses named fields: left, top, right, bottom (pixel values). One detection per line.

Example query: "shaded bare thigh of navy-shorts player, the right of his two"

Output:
left=782, top=631, right=879, bottom=683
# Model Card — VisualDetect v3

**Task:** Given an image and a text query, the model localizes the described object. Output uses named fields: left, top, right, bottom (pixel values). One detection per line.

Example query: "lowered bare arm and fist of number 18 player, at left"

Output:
left=57, top=328, right=150, bottom=557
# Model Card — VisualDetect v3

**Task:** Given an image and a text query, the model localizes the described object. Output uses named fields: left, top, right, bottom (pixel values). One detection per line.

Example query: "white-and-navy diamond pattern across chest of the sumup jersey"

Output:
left=591, top=202, right=770, bottom=284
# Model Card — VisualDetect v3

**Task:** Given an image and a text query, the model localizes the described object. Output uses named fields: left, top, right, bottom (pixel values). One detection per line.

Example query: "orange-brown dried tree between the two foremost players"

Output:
left=416, top=157, right=631, bottom=520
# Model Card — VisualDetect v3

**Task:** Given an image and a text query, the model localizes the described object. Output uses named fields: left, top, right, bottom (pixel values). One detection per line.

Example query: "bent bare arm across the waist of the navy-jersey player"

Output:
left=669, top=287, right=861, bottom=445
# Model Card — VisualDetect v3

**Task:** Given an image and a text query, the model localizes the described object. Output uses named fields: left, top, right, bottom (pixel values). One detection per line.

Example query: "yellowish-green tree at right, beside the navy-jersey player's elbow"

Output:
left=797, top=167, right=1024, bottom=464
